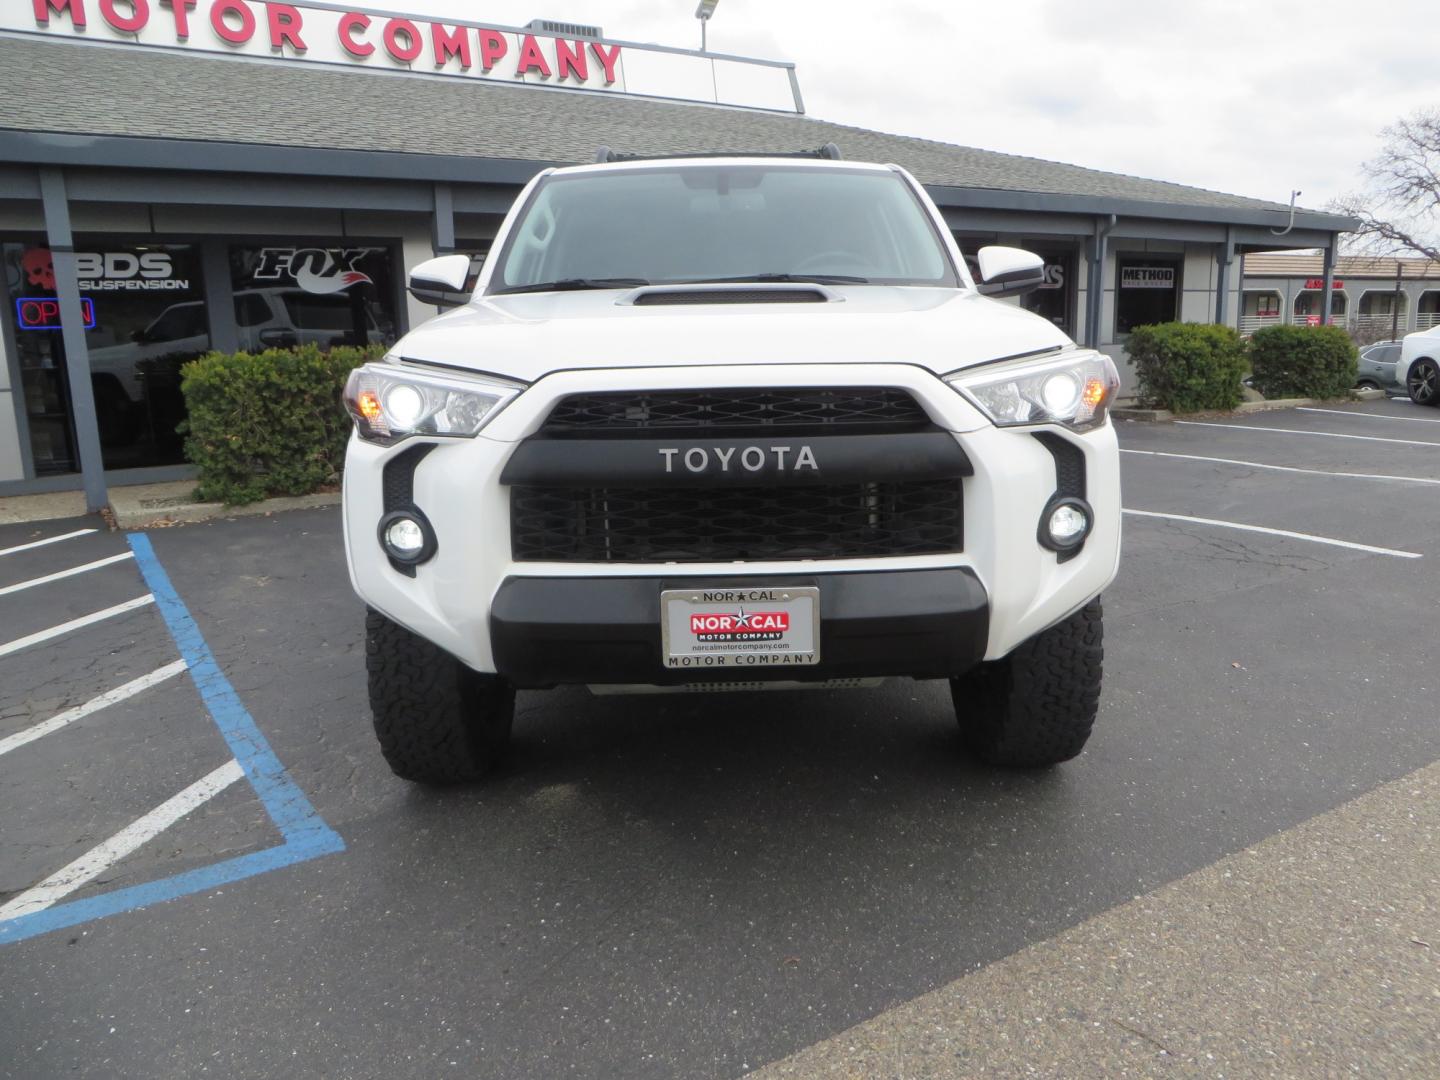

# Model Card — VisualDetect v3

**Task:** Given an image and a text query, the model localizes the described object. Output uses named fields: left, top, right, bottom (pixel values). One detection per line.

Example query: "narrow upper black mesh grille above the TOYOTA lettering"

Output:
left=540, top=386, right=930, bottom=436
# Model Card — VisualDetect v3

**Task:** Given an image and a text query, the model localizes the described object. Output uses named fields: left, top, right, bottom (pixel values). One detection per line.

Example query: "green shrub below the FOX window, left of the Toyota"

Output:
left=180, top=346, right=383, bottom=505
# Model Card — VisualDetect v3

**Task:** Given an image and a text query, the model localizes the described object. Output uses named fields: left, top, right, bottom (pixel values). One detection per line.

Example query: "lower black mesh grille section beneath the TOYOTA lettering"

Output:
left=510, top=480, right=965, bottom=563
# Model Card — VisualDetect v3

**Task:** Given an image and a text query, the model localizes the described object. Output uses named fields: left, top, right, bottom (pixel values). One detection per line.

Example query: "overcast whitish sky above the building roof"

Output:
left=400, top=0, right=1440, bottom=207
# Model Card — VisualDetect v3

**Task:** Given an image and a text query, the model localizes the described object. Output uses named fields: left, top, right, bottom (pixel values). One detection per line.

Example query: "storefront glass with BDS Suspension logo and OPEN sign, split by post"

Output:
left=4, top=236, right=210, bottom=475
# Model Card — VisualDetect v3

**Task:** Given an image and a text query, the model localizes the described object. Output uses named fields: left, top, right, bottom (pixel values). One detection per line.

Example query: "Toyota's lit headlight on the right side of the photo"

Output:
left=945, top=351, right=1120, bottom=429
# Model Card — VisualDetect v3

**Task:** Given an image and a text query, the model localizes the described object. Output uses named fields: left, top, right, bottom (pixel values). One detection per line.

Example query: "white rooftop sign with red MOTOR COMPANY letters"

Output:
left=12, top=0, right=625, bottom=91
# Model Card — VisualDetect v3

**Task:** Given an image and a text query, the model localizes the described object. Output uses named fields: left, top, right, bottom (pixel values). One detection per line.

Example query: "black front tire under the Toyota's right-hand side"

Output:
left=950, top=598, right=1104, bottom=769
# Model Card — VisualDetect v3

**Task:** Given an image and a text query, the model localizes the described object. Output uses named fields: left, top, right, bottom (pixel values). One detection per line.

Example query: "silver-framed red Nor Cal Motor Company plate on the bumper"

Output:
left=660, top=586, right=819, bottom=671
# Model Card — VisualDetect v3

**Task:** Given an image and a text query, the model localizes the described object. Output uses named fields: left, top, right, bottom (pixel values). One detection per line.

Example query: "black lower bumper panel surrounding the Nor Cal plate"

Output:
left=490, top=567, right=989, bottom=688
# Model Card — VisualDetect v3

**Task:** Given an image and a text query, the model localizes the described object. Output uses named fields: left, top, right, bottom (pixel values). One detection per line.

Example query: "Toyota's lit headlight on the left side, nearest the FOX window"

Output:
left=346, top=363, right=524, bottom=442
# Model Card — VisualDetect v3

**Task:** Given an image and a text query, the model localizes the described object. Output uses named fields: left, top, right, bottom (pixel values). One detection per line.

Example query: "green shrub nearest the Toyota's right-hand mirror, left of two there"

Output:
left=1125, top=323, right=1248, bottom=412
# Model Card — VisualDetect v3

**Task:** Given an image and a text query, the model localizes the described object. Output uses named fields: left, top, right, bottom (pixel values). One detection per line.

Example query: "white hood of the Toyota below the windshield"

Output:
left=392, top=285, right=1071, bottom=383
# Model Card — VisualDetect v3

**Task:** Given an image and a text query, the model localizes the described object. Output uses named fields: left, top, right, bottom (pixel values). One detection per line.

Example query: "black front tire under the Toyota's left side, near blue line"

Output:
left=364, top=611, right=516, bottom=785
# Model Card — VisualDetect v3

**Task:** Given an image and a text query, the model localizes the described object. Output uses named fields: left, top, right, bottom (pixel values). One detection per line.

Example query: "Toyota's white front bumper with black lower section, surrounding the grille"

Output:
left=344, top=364, right=1120, bottom=685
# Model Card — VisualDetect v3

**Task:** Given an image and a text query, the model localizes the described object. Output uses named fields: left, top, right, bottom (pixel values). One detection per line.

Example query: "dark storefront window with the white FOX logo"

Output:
left=230, top=245, right=396, bottom=351
